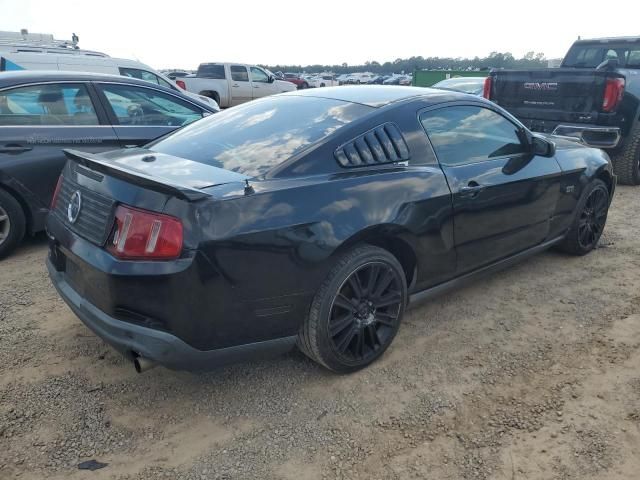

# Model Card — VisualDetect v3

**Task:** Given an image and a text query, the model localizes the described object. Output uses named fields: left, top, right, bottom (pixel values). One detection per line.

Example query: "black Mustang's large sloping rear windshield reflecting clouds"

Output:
left=147, top=95, right=373, bottom=176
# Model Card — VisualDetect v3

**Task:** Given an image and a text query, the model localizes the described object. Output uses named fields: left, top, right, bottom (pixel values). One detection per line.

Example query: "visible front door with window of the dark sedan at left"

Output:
left=95, top=82, right=206, bottom=147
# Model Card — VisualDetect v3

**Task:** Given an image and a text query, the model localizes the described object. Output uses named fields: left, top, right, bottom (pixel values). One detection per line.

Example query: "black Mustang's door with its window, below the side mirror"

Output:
left=420, top=105, right=561, bottom=273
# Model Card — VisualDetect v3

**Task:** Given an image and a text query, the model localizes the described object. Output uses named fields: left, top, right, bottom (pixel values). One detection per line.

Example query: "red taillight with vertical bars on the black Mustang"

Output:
left=107, top=205, right=182, bottom=260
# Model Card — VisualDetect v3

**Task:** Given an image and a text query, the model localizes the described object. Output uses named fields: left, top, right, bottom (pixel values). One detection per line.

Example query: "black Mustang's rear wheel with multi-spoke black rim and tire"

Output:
left=298, top=245, right=407, bottom=373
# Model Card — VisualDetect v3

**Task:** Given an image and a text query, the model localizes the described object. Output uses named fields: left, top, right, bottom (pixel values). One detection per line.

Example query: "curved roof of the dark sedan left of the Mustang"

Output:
left=0, top=70, right=170, bottom=89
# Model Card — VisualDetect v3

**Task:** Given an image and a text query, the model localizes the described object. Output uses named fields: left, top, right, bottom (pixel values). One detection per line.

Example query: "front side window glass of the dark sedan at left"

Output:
left=101, top=84, right=202, bottom=126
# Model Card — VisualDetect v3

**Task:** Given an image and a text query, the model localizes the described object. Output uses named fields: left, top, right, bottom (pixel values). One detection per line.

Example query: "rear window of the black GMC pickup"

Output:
left=562, top=43, right=640, bottom=68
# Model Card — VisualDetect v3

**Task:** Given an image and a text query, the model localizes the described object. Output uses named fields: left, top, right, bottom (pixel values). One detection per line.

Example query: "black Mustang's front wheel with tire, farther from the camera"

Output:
left=559, top=179, right=609, bottom=255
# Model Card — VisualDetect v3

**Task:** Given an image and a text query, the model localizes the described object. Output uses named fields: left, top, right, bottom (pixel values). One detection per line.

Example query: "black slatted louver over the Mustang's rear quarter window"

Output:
left=334, top=123, right=409, bottom=168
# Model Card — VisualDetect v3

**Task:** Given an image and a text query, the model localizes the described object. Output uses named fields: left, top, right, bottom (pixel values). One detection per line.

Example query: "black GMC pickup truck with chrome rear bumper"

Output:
left=483, top=37, right=640, bottom=185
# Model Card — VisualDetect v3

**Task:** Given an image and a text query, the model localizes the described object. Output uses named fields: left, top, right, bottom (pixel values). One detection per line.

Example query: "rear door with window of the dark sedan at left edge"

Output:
left=0, top=82, right=119, bottom=211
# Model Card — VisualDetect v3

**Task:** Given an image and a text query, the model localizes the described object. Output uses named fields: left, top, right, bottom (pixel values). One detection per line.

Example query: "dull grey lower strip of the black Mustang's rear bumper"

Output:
left=47, top=259, right=296, bottom=370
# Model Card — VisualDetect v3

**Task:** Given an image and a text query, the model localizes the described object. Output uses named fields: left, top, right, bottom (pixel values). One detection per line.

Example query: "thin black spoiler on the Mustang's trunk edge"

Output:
left=63, top=150, right=210, bottom=202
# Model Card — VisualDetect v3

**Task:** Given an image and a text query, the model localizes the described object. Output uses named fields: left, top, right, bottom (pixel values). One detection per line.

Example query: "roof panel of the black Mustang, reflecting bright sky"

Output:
left=281, top=85, right=478, bottom=108
